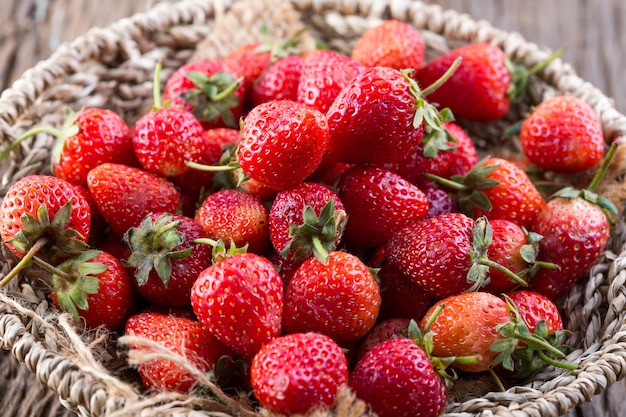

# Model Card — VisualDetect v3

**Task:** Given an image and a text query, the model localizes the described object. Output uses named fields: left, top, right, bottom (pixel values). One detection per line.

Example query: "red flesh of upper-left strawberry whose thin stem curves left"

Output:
left=52, top=108, right=138, bottom=186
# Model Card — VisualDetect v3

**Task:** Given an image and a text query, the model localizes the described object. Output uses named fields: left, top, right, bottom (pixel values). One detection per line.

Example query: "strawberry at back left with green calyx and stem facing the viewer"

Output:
left=163, top=60, right=247, bottom=129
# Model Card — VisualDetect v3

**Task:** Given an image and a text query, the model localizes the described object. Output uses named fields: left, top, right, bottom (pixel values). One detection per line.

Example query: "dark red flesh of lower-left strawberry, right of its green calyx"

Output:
left=51, top=252, right=135, bottom=330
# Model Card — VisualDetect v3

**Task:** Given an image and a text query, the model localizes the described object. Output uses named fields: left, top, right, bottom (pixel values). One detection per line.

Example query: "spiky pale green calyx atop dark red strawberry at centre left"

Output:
left=122, top=213, right=193, bottom=288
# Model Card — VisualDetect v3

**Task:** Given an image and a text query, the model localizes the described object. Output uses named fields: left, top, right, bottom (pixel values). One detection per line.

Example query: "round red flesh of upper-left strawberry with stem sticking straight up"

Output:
left=133, top=107, right=204, bottom=177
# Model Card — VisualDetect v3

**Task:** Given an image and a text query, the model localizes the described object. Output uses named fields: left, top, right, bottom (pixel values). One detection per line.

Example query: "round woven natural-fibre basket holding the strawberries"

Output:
left=0, top=0, right=626, bottom=417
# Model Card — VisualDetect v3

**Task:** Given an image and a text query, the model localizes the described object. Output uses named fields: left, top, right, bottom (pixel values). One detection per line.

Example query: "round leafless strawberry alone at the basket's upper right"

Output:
left=519, top=96, right=604, bottom=173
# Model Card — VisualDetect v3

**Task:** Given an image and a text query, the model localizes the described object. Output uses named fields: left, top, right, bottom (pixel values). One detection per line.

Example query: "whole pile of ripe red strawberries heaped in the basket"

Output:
left=0, top=20, right=615, bottom=417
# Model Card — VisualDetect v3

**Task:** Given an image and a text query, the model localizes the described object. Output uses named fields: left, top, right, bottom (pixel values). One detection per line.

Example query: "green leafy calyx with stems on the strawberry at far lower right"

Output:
left=489, top=295, right=578, bottom=378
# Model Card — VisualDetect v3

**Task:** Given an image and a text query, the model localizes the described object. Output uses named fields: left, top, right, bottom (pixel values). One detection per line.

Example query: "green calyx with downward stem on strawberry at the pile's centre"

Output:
left=280, top=199, right=347, bottom=263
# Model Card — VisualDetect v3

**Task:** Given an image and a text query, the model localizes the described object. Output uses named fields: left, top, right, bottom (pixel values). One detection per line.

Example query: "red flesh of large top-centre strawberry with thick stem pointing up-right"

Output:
left=327, top=67, right=422, bottom=164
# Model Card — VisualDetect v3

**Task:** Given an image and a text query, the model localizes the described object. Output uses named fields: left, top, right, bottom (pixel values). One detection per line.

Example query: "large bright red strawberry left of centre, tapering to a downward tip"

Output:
left=191, top=253, right=283, bottom=359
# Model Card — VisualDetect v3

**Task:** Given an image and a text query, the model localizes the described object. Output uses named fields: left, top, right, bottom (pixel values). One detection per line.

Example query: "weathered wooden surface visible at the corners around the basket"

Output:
left=0, top=0, right=626, bottom=417
